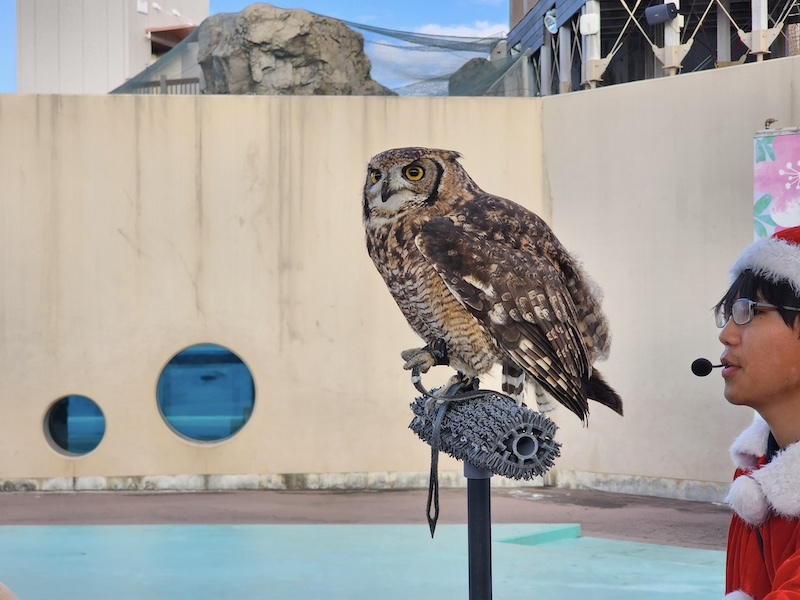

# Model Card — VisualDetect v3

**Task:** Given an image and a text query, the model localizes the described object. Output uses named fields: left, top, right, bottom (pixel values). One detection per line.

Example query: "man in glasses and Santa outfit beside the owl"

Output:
left=716, top=227, right=800, bottom=600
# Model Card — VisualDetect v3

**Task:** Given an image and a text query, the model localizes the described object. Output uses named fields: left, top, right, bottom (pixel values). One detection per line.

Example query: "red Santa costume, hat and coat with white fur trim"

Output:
left=725, top=228, right=800, bottom=600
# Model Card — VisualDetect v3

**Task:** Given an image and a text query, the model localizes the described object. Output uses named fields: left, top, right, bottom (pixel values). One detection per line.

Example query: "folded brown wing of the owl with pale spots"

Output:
left=415, top=217, right=589, bottom=418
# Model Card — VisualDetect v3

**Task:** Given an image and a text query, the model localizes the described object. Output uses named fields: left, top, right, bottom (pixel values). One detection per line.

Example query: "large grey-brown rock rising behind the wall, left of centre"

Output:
left=198, top=4, right=394, bottom=96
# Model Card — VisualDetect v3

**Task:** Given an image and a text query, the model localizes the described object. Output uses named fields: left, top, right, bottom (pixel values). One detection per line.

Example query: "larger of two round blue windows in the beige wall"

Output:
left=156, top=344, right=255, bottom=442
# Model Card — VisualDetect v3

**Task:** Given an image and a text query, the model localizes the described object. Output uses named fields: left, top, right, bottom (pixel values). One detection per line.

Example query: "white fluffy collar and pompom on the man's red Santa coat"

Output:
left=725, top=415, right=800, bottom=526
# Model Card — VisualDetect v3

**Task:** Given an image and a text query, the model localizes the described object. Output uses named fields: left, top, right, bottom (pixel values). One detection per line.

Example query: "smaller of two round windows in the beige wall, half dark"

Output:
left=44, top=396, right=106, bottom=455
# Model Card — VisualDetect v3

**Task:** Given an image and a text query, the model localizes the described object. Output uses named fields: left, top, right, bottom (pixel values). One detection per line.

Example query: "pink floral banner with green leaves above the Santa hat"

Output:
left=753, top=128, right=800, bottom=239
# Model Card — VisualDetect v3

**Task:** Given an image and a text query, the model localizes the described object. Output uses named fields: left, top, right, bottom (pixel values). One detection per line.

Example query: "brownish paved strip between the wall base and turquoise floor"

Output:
left=0, top=488, right=730, bottom=550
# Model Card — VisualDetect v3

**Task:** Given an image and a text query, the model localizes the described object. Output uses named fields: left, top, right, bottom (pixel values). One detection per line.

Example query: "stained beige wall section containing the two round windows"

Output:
left=0, top=96, right=542, bottom=487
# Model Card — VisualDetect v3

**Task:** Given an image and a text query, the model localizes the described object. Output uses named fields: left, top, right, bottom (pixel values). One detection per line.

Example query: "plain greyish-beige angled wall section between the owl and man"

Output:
left=543, top=59, right=800, bottom=496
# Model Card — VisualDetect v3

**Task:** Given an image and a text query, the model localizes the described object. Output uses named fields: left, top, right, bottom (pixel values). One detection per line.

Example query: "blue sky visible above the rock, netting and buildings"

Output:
left=0, top=0, right=509, bottom=94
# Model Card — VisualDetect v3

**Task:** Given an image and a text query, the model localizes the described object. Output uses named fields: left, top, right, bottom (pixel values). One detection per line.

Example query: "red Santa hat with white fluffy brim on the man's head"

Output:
left=731, top=227, right=800, bottom=296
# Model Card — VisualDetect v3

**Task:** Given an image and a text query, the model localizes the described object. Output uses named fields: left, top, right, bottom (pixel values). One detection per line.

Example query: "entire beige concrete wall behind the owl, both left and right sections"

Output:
left=0, top=59, right=800, bottom=498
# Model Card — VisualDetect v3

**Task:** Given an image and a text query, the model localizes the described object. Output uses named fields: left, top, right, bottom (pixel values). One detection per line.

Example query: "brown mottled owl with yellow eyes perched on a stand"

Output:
left=363, top=148, right=622, bottom=423
